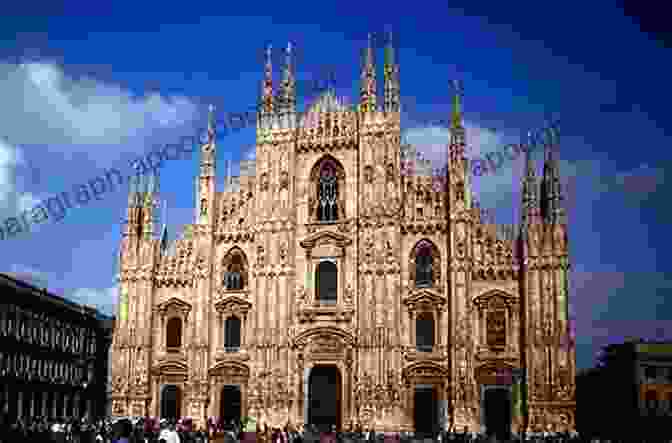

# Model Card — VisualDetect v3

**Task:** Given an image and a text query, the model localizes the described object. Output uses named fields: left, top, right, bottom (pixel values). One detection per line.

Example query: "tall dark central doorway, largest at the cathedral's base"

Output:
left=308, top=366, right=341, bottom=432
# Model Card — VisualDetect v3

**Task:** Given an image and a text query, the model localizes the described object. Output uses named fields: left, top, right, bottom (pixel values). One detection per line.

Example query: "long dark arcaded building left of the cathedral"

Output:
left=0, top=274, right=112, bottom=421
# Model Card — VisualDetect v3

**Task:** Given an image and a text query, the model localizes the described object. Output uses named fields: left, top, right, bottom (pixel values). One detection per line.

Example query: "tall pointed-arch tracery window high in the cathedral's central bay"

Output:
left=308, top=154, right=345, bottom=222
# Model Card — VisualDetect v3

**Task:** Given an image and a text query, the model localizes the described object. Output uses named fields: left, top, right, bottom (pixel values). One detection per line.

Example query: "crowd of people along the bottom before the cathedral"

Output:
left=0, top=416, right=672, bottom=443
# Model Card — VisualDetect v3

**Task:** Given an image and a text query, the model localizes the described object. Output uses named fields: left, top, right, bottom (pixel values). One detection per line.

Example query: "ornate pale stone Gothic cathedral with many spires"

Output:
left=112, top=35, right=575, bottom=433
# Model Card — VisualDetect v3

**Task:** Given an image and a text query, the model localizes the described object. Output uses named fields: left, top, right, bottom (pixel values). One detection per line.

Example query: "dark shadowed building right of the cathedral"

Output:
left=577, top=340, right=672, bottom=438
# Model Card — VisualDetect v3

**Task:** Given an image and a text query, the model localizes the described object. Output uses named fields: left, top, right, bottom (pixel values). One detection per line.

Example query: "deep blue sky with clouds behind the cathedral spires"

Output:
left=0, top=0, right=672, bottom=367
